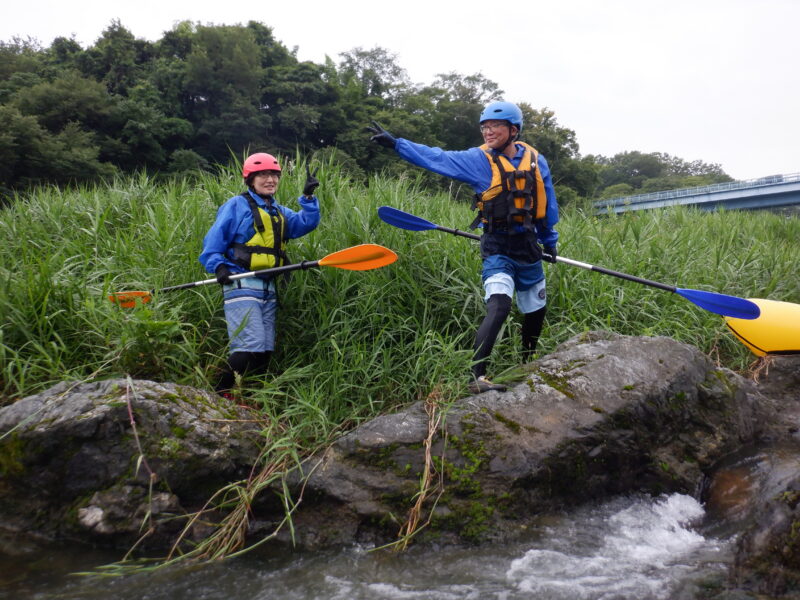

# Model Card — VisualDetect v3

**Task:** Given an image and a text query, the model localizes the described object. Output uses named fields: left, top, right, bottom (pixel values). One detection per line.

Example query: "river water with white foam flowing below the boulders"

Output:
left=0, top=494, right=733, bottom=600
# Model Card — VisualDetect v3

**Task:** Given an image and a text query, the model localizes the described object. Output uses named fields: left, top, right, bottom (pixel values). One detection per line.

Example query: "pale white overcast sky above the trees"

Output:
left=0, top=0, right=800, bottom=179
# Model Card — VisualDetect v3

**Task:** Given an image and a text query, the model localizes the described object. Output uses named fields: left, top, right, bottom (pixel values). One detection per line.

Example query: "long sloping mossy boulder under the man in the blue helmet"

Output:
left=274, top=333, right=777, bottom=547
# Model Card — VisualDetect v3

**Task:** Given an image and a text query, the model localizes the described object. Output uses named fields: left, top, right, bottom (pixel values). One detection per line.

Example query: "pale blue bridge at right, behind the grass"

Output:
left=594, top=173, right=800, bottom=215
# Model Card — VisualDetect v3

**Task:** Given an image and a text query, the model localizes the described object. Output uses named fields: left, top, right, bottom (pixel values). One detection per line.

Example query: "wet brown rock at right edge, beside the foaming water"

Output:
left=702, top=356, right=800, bottom=598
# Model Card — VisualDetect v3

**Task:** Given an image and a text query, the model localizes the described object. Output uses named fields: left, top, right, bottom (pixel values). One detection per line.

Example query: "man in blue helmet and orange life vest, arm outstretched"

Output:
left=367, top=102, right=558, bottom=393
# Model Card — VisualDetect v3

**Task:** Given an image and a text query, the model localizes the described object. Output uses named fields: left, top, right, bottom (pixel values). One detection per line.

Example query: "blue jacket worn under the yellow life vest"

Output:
left=200, top=190, right=319, bottom=273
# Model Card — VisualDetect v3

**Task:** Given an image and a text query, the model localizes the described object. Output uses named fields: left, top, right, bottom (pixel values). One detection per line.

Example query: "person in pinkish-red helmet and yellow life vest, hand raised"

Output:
left=200, top=152, right=320, bottom=398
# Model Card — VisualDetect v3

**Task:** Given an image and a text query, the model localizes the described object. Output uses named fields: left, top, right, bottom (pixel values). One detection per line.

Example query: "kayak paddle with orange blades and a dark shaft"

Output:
left=108, top=244, right=397, bottom=308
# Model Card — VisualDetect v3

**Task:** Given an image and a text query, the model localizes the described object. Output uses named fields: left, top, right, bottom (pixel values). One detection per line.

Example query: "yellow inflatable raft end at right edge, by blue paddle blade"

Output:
left=725, top=298, right=800, bottom=356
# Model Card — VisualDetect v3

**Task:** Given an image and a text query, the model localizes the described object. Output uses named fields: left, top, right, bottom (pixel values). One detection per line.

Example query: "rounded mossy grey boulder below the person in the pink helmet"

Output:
left=0, top=379, right=259, bottom=547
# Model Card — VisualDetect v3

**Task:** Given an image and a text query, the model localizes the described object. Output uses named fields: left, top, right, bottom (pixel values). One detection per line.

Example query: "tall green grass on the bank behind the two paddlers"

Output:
left=0, top=158, right=800, bottom=428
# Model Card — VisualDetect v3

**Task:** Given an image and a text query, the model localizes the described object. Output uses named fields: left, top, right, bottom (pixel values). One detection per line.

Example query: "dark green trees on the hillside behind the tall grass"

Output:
left=0, top=20, right=730, bottom=203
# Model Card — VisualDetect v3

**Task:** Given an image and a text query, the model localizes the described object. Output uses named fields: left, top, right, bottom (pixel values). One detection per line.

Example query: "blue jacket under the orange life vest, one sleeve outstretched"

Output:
left=395, top=138, right=558, bottom=246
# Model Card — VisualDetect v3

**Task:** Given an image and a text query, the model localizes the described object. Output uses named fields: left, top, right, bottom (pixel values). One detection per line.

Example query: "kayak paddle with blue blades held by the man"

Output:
left=378, top=206, right=761, bottom=319
